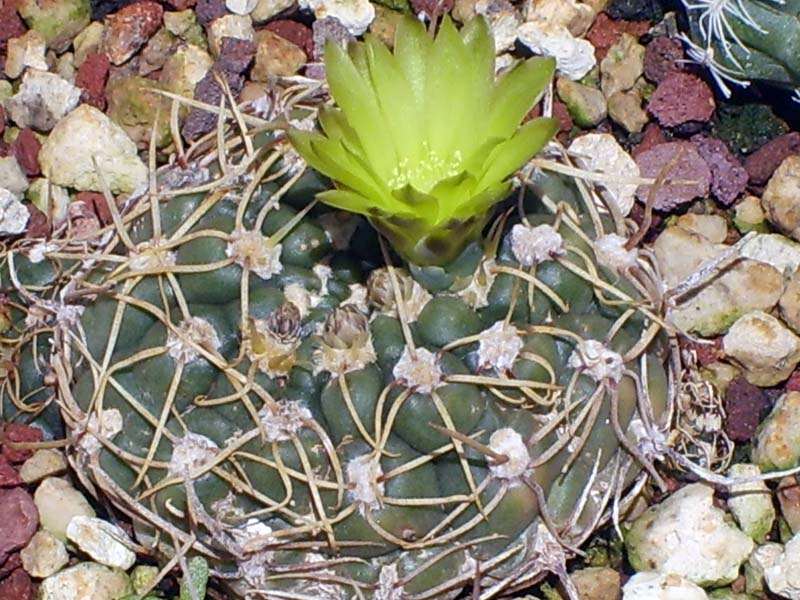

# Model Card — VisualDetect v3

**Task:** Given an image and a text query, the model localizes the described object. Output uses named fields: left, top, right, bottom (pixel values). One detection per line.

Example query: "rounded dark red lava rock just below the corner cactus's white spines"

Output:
left=647, top=73, right=716, bottom=127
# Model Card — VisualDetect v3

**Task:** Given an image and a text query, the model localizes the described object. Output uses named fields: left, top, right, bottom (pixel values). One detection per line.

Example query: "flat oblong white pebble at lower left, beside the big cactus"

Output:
left=66, top=515, right=136, bottom=571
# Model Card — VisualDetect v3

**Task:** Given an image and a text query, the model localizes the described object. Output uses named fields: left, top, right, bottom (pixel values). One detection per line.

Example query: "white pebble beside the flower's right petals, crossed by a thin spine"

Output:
left=569, top=133, right=639, bottom=216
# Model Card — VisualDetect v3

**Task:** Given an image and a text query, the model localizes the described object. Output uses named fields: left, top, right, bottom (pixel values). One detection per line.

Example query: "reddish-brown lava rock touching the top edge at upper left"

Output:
left=103, top=0, right=164, bottom=65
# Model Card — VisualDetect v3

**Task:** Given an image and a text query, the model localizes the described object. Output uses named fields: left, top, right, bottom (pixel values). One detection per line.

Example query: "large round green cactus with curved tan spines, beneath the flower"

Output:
left=6, top=14, right=675, bottom=600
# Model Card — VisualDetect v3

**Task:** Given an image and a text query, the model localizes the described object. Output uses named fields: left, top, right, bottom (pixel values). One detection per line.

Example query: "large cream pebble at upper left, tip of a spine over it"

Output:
left=39, top=104, right=147, bottom=194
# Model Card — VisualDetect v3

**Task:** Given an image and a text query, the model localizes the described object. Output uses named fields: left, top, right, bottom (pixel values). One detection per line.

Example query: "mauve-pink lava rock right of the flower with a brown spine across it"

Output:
left=636, top=142, right=711, bottom=211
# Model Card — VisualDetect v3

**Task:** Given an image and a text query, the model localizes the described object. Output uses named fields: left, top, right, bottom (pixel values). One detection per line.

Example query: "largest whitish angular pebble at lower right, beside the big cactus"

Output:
left=625, top=483, right=755, bottom=587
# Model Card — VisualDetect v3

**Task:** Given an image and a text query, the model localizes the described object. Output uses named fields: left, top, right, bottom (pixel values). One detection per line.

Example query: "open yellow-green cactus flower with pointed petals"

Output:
left=289, top=16, right=557, bottom=265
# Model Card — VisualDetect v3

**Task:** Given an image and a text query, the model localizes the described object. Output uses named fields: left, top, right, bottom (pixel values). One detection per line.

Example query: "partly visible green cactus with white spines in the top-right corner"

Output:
left=680, top=0, right=800, bottom=98
